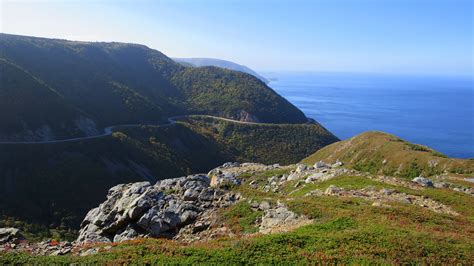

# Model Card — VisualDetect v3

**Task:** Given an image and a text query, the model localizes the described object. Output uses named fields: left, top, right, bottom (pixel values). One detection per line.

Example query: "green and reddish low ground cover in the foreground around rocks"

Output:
left=0, top=167, right=474, bottom=265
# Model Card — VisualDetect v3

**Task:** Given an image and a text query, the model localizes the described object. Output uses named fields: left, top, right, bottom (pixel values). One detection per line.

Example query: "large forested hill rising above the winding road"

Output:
left=0, top=34, right=307, bottom=140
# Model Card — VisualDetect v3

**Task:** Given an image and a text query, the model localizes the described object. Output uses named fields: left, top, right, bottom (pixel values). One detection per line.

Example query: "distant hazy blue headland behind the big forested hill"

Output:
left=172, top=57, right=270, bottom=83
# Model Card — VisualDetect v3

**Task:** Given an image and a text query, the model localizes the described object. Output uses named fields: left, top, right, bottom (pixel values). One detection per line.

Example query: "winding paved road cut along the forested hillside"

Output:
left=0, top=115, right=274, bottom=144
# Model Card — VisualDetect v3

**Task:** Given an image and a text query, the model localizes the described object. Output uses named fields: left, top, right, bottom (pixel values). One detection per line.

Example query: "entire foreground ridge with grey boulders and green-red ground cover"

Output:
left=0, top=163, right=474, bottom=265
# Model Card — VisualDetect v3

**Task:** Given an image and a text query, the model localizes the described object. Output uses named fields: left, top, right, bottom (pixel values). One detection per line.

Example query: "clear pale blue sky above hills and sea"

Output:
left=0, top=0, right=474, bottom=76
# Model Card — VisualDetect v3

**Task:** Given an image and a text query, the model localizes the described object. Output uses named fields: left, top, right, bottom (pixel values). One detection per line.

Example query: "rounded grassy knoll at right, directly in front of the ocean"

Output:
left=302, top=132, right=474, bottom=178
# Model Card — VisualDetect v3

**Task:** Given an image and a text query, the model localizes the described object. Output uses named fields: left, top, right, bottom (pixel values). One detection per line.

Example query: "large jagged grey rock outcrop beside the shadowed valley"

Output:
left=77, top=174, right=239, bottom=242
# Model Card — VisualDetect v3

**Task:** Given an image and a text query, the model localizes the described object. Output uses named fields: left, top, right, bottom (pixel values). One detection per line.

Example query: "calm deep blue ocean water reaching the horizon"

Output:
left=264, top=72, right=474, bottom=158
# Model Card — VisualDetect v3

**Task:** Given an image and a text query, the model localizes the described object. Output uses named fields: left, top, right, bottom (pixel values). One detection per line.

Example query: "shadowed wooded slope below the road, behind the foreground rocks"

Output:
left=0, top=118, right=335, bottom=237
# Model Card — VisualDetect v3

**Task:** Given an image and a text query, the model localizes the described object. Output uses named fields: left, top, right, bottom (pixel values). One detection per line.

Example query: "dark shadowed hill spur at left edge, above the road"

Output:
left=0, top=58, right=98, bottom=141
